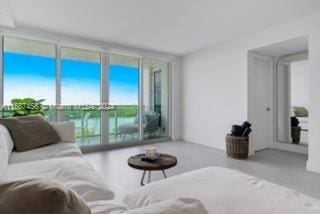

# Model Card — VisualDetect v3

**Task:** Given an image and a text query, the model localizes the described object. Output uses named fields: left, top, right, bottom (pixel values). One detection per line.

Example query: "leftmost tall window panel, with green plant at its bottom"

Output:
left=3, top=37, right=56, bottom=121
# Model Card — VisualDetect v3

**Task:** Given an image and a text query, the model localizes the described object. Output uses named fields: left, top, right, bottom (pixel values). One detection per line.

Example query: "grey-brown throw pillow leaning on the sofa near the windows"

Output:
left=0, top=115, right=60, bottom=152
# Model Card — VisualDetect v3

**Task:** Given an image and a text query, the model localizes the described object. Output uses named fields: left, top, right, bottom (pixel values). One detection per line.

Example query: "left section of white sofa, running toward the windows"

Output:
left=0, top=122, right=114, bottom=212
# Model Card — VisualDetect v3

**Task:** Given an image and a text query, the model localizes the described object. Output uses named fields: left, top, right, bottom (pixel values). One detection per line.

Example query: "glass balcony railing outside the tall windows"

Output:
left=2, top=105, right=162, bottom=146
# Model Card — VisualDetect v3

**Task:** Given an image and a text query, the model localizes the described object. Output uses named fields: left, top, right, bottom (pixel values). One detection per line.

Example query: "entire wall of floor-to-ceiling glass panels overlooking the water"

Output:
left=0, top=37, right=170, bottom=149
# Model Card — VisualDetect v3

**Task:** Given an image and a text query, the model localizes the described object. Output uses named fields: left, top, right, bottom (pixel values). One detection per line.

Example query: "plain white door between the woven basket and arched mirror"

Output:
left=248, top=53, right=273, bottom=154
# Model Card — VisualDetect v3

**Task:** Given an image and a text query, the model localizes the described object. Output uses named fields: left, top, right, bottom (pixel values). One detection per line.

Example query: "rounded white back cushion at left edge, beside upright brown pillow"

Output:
left=0, top=124, right=13, bottom=176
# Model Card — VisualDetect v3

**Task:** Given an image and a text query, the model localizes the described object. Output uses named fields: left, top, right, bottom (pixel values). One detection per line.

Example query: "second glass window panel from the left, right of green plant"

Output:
left=59, top=48, right=101, bottom=146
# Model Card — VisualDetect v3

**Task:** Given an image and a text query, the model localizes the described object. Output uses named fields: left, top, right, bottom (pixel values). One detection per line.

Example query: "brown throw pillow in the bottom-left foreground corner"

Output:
left=0, top=180, right=91, bottom=214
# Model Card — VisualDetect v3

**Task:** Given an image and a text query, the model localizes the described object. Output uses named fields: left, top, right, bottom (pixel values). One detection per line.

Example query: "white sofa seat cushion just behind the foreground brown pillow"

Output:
left=1, top=157, right=114, bottom=202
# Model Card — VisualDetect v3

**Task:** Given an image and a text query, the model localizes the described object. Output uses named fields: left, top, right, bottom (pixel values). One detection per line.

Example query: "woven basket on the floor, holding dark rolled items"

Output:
left=226, top=135, right=249, bottom=159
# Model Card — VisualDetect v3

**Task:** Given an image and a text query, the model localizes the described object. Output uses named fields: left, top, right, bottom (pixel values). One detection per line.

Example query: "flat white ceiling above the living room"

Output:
left=5, top=0, right=320, bottom=55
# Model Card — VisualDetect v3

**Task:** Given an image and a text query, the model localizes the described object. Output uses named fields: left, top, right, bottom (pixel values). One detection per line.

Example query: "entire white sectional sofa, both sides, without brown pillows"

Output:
left=0, top=122, right=320, bottom=214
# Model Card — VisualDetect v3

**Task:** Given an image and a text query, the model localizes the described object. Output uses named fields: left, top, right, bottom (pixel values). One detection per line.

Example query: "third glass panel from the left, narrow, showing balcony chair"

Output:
left=108, top=55, right=140, bottom=143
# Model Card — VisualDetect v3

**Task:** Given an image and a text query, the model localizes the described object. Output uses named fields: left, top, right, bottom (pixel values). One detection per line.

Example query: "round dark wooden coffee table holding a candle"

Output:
left=128, top=153, right=178, bottom=186
